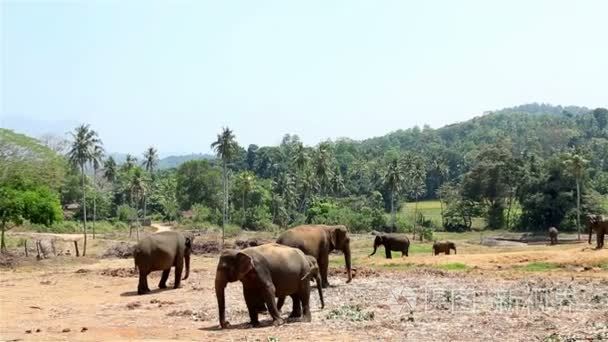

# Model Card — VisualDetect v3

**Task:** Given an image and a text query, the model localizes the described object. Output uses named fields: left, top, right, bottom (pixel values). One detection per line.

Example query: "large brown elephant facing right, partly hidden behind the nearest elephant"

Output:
left=277, top=225, right=353, bottom=288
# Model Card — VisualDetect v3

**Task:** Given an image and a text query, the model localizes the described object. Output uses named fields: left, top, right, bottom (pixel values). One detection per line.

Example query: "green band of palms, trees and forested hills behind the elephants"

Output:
left=0, top=104, right=608, bottom=252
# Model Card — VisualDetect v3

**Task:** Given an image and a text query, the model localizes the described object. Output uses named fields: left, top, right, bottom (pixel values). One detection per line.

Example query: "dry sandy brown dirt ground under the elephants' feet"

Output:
left=0, top=234, right=608, bottom=341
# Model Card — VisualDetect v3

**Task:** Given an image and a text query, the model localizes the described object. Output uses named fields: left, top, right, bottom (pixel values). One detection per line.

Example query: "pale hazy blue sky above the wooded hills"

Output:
left=0, top=0, right=608, bottom=155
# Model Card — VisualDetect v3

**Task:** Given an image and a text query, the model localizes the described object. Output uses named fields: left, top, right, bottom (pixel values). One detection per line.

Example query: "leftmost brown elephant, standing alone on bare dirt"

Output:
left=133, top=231, right=192, bottom=295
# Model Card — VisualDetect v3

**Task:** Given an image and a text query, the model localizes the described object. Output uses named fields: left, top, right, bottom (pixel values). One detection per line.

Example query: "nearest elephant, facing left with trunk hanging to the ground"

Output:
left=215, top=243, right=314, bottom=328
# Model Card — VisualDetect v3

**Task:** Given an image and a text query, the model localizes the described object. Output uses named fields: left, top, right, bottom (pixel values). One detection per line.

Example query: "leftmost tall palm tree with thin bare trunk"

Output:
left=68, top=124, right=102, bottom=256
